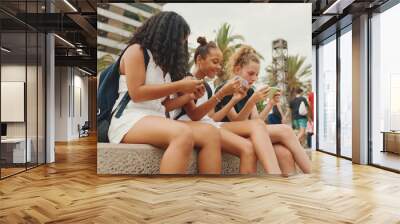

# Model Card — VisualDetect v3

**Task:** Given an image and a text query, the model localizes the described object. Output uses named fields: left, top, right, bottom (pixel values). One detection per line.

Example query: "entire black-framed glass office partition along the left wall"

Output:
left=0, top=0, right=46, bottom=178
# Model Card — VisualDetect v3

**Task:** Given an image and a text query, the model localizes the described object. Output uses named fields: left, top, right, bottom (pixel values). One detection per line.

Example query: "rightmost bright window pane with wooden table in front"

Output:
left=371, top=4, right=400, bottom=170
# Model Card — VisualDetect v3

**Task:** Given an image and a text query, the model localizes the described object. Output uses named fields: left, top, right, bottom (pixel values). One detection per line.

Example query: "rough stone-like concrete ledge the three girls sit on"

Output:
left=97, top=143, right=311, bottom=175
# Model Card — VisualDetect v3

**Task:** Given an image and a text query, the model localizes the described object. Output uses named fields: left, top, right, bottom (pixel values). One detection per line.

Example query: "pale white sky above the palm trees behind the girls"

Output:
left=163, top=3, right=312, bottom=82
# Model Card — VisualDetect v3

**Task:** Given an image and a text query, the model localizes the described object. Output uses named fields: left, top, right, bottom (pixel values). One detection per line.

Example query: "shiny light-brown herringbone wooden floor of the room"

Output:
left=0, top=138, right=400, bottom=224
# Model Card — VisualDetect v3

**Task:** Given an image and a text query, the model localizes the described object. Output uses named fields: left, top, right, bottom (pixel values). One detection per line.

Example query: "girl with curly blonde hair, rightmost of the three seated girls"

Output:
left=216, top=46, right=311, bottom=173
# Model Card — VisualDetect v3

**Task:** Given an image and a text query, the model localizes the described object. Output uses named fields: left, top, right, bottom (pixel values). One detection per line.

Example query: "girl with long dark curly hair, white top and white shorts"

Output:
left=108, top=12, right=221, bottom=174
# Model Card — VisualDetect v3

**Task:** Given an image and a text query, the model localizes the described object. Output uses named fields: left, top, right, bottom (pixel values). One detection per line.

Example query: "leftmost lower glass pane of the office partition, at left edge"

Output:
left=0, top=32, right=30, bottom=178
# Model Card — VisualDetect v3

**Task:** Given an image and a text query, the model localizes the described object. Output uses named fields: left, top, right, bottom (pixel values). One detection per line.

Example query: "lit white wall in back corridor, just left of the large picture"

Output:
left=55, top=67, right=88, bottom=141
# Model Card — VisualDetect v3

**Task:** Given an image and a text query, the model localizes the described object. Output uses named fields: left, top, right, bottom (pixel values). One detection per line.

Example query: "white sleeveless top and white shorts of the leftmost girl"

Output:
left=108, top=50, right=171, bottom=143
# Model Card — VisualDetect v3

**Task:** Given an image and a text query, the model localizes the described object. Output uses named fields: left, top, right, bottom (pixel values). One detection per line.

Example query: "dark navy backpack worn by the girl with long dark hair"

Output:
left=97, top=48, right=150, bottom=142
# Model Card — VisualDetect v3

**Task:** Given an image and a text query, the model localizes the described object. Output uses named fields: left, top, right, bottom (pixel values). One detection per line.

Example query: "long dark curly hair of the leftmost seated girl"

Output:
left=128, top=11, right=190, bottom=81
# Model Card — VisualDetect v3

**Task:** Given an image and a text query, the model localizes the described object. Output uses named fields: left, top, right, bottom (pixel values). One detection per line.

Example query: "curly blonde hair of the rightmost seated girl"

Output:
left=227, top=45, right=260, bottom=78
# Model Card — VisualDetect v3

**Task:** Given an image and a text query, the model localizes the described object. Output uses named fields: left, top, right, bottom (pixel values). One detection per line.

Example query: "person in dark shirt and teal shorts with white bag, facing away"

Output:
left=289, top=88, right=309, bottom=144
